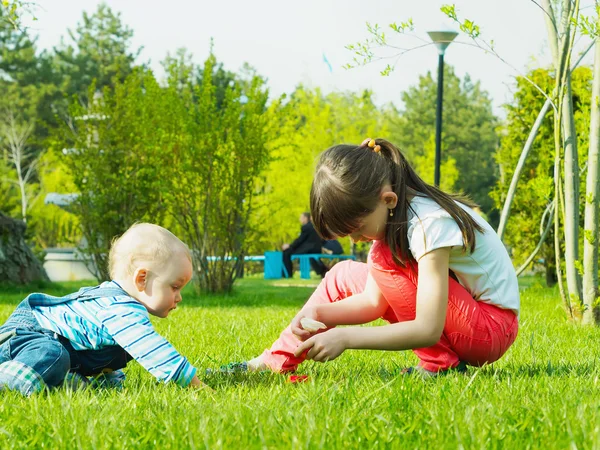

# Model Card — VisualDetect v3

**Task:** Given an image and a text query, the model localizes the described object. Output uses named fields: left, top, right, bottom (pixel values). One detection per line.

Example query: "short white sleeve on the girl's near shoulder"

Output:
left=408, top=216, right=464, bottom=261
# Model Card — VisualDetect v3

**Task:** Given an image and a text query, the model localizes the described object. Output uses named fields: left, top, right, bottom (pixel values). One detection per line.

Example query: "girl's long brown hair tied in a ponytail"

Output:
left=310, top=139, right=483, bottom=265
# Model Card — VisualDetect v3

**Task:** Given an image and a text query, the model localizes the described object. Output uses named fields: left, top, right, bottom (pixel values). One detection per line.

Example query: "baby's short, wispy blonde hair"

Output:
left=108, top=223, right=192, bottom=279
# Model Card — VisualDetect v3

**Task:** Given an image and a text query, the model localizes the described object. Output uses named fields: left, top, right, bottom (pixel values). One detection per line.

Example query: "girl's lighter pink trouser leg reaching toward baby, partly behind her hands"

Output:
left=254, top=261, right=368, bottom=372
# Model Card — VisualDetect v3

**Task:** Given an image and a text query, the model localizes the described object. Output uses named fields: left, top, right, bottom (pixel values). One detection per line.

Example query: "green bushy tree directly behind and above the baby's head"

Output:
left=53, top=69, right=173, bottom=280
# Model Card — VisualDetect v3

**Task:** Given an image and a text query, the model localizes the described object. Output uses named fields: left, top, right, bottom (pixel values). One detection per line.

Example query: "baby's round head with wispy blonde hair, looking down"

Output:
left=108, top=223, right=192, bottom=317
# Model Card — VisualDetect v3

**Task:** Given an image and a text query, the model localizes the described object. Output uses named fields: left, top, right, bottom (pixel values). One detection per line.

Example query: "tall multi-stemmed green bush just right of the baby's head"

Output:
left=165, top=54, right=270, bottom=292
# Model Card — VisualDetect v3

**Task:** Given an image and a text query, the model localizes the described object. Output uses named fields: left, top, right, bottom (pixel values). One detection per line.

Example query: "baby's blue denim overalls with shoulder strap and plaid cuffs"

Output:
left=0, top=288, right=131, bottom=395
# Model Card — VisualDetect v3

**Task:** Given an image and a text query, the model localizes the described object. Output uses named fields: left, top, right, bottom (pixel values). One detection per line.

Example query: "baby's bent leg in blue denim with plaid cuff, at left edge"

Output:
left=0, top=329, right=70, bottom=395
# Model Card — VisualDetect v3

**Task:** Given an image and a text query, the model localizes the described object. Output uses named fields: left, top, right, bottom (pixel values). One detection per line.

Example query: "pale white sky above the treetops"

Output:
left=22, top=0, right=593, bottom=117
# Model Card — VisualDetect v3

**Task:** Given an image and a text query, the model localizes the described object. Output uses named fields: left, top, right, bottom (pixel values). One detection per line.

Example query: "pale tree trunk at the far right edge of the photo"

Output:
left=583, top=38, right=600, bottom=324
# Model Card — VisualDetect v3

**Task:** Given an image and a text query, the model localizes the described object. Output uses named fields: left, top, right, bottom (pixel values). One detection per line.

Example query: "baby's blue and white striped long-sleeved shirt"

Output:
left=32, top=282, right=196, bottom=386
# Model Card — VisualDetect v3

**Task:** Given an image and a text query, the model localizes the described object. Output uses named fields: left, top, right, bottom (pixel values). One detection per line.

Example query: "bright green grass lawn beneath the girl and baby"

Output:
left=0, top=279, right=600, bottom=449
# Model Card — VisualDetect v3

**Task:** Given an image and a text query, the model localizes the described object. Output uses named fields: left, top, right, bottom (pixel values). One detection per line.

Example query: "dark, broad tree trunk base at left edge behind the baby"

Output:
left=0, top=213, right=48, bottom=284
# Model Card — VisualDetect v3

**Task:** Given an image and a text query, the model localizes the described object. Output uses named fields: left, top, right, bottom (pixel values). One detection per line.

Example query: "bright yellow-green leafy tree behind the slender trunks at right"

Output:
left=492, top=67, right=591, bottom=285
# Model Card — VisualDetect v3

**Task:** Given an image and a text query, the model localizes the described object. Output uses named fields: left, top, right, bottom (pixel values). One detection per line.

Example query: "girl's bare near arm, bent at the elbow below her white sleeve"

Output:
left=295, top=247, right=450, bottom=361
